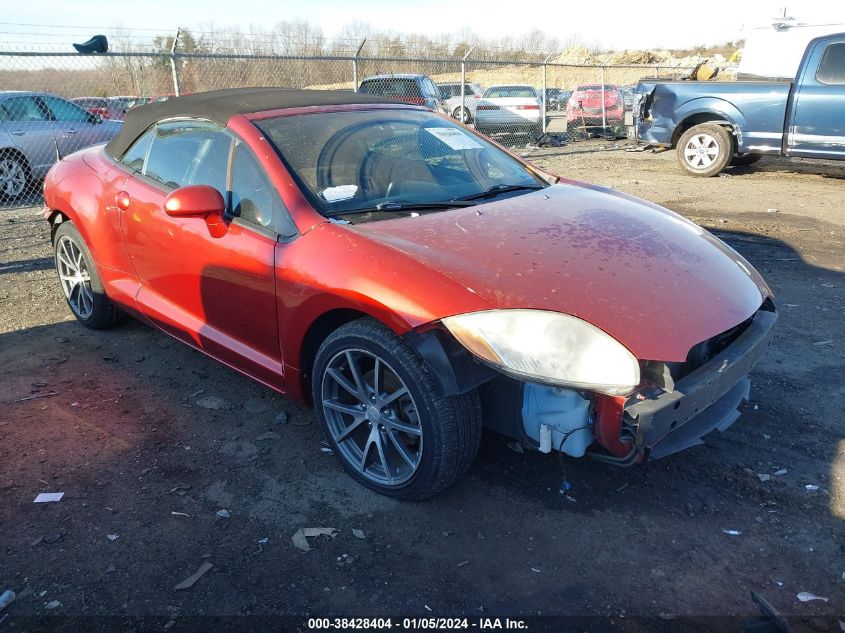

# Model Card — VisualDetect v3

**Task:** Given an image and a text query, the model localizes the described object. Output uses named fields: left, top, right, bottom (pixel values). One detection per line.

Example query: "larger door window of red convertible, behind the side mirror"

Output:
left=144, top=121, right=232, bottom=191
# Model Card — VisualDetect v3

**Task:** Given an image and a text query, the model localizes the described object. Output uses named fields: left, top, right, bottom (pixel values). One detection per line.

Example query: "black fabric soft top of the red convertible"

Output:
left=101, top=88, right=400, bottom=159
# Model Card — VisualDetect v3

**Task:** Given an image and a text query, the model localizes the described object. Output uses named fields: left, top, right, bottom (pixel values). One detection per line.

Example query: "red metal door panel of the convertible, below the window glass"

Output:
left=122, top=169, right=281, bottom=382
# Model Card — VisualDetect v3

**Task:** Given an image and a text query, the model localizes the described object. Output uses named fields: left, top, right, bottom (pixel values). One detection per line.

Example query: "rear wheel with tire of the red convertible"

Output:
left=53, top=221, right=123, bottom=330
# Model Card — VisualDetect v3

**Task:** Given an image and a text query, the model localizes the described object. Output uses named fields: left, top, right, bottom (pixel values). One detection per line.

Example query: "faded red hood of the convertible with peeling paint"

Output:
left=352, top=181, right=769, bottom=361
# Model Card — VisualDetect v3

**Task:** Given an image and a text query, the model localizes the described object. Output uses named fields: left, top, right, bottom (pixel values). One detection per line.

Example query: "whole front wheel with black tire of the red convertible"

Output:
left=312, top=318, right=481, bottom=500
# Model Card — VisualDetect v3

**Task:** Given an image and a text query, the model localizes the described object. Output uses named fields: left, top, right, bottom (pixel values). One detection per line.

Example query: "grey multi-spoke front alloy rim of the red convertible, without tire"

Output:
left=321, top=349, right=423, bottom=487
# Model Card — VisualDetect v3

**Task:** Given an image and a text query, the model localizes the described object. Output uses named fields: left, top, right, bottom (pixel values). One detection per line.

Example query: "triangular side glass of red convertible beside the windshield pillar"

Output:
left=231, top=143, right=296, bottom=236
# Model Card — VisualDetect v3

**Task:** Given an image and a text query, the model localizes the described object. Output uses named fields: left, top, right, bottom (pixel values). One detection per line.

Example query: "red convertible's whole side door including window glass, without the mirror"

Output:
left=121, top=120, right=282, bottom=388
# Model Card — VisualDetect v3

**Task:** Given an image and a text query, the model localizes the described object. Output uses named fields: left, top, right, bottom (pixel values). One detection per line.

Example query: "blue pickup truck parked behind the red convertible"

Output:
left=634, top=33, right=845, bottom=177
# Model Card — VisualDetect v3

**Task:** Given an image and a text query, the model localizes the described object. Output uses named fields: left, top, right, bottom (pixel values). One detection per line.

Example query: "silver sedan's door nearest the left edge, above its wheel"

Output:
left=0, top=95, right=58, bottom=178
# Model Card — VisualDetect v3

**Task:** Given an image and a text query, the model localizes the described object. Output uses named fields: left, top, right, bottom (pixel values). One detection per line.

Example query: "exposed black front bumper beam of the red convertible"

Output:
left=623, top=308, right=778, bottom=458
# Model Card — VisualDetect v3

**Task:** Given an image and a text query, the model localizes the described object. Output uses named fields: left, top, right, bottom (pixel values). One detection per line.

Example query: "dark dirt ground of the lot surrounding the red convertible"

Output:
left=0, top=141, right=845, bottom=631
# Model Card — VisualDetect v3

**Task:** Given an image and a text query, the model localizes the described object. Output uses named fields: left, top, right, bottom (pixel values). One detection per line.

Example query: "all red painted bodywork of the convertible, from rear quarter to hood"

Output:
left=45, top=99, right=770, bottom=455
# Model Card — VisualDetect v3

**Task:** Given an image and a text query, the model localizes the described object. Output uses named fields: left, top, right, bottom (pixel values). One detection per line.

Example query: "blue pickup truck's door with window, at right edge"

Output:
left=787, top=41, right=845, bottom=159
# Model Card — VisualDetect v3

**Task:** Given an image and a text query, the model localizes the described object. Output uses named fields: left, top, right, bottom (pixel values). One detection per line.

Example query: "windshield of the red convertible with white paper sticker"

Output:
left=256, top=109, right=548, bottom=215
